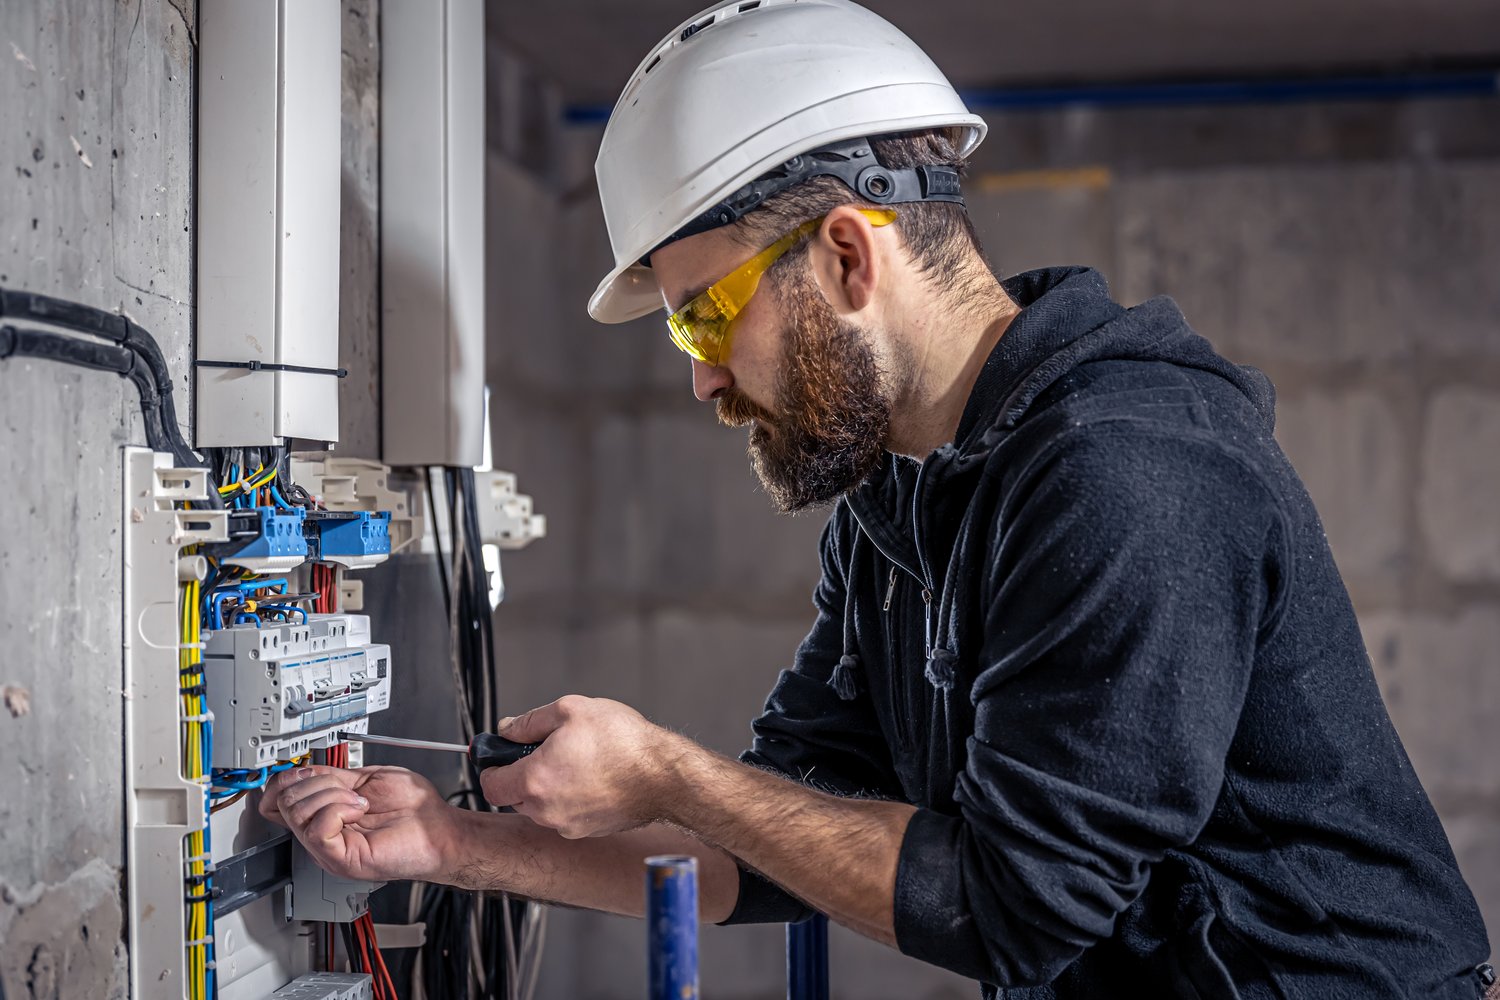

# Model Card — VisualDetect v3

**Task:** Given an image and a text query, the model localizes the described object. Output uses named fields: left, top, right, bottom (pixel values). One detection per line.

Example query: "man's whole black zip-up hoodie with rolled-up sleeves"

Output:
left=729, top=268, right=1488, bottom=1000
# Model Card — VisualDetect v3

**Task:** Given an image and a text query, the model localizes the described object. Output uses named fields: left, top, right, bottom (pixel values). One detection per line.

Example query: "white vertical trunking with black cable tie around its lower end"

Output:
left=197, top=0, right=341, bottom=447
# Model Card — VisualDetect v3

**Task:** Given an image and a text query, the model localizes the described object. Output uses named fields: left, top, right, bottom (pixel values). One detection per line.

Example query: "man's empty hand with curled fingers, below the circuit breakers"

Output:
left=260, top=766, right=458, bottom=882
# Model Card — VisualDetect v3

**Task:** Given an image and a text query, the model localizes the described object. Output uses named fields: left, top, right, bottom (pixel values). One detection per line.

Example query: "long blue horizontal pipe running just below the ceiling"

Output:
left=563, top=67, right=1500, bottom=124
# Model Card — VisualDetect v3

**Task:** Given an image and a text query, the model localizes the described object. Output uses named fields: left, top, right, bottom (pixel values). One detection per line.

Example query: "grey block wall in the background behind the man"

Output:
left=491, top=100, right=1500, bottom=1000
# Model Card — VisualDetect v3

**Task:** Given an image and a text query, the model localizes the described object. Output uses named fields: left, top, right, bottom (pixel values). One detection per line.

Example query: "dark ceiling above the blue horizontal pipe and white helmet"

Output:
left=488, top=0, right=1500, bottom=103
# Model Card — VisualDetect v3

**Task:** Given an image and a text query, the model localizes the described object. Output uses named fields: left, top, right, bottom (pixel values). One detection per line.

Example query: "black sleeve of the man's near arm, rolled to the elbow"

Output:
left=896, top=424, right=1286, bottom=987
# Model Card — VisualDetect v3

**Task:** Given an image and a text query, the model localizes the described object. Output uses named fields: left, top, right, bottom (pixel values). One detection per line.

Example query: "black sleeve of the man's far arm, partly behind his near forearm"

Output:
left=725, top=504, right=900, bottom=924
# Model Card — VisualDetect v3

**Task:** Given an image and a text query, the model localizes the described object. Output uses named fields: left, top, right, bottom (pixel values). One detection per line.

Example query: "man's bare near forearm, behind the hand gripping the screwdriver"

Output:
left=663, top=736, right=915, bottom=946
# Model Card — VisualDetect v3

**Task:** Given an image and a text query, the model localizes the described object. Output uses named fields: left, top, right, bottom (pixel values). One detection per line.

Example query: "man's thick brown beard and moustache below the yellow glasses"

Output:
left=717, top=256, right=891, bottom=514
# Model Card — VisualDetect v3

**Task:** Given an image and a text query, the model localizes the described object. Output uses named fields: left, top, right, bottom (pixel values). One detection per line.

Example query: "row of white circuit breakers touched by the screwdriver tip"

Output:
left=204, top=615, right=392, bottom=769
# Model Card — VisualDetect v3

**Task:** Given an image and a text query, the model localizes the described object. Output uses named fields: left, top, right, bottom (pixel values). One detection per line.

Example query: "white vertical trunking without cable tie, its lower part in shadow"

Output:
left=380, top=0, right=485, bottom=466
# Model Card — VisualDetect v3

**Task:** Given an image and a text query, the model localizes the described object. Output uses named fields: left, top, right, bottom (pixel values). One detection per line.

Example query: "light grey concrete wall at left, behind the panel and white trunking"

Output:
left=0, top=0, right=380, bottom=1000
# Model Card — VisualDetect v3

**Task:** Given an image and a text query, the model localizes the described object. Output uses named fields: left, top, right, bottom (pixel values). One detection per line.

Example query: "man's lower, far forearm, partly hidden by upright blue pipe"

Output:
left=434, top=810, right=740, bottom=922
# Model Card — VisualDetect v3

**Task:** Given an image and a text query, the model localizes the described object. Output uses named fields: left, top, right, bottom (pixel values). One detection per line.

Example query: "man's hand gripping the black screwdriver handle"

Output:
left=480, top=694, right=674, bottom=840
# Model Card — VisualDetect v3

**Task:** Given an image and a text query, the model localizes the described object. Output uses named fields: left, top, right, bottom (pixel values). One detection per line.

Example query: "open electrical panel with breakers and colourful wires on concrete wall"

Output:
left=123, top=448, right=423, bottom=1000
